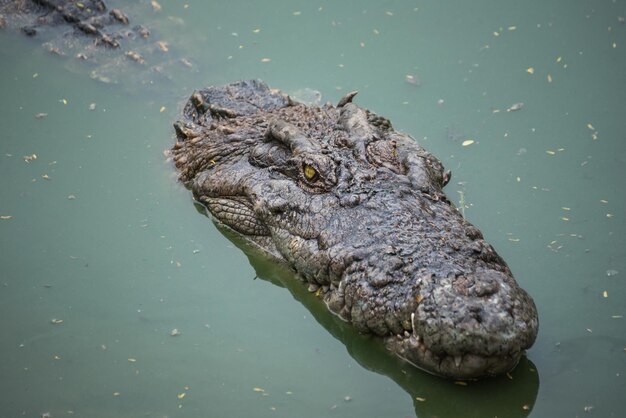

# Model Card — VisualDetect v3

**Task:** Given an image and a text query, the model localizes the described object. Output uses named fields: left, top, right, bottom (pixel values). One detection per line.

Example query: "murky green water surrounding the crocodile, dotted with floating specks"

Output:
left=0, top=0, right=626, bottom=418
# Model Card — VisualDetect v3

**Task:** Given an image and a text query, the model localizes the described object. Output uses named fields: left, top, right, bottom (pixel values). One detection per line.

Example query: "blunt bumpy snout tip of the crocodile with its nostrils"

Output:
left=387, top=269, right=538, bottom=378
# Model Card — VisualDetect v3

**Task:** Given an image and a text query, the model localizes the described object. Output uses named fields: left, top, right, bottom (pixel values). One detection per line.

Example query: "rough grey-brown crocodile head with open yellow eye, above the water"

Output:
left=171, top=80, right=538, bottom=379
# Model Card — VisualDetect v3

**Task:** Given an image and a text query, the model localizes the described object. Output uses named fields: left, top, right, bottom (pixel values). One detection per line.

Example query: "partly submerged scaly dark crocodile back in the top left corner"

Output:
left=0, top=0, right=195, bottom=91
